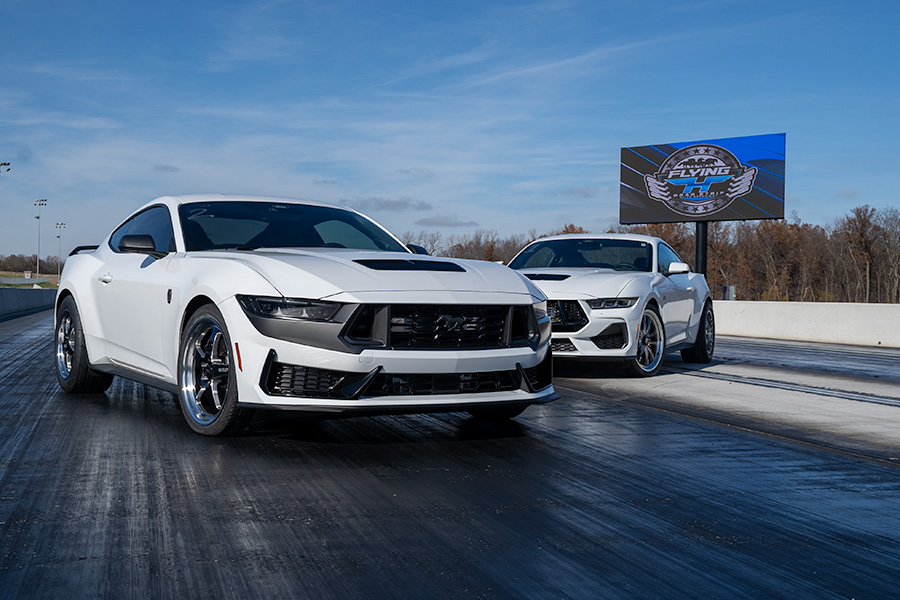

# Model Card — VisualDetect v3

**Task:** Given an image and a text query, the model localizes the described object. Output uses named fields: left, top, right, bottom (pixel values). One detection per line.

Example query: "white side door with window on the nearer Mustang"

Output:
left=94, top=206, right=175, bottom=379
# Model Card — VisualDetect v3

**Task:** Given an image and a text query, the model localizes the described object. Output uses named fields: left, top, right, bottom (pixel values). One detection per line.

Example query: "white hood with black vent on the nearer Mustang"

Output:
left=194, top=248, right=543, bottom=303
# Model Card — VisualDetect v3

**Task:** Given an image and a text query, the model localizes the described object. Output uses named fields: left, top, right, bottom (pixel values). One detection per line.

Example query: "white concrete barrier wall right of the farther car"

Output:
left=713, top=300, right=900, bottom=348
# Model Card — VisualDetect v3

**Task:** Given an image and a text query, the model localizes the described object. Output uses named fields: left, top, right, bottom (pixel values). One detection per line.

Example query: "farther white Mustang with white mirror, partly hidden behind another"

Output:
left=509, top=234, right=716, bottom=377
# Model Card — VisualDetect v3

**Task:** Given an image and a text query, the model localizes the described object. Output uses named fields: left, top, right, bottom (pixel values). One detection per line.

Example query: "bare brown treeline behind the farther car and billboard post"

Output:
left=403, top=205, right=900, bottom=303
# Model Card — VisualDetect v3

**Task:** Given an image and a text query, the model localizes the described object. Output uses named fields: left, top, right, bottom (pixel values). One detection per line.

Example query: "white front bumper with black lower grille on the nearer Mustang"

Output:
left=220, top=299, right=557, bottom=414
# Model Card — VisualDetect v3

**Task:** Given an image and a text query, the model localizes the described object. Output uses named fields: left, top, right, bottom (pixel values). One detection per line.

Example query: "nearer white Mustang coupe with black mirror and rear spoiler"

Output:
left=55, top=195, right=556, bottom=435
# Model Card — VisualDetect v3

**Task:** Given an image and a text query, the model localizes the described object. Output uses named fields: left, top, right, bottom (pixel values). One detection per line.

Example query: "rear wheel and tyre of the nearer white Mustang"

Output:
left=55, top=296, right=113, bottom=394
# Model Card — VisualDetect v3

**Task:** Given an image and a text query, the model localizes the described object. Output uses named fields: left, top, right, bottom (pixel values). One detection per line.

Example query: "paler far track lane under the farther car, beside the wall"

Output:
left=554, top=338, right=900, bottom=463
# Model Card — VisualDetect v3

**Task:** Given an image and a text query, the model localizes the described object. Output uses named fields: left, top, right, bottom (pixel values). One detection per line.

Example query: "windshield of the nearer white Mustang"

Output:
left=178, top=201, right=408, bottom=252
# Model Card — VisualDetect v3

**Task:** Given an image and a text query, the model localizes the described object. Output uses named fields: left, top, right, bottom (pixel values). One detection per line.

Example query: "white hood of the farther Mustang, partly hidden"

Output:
left=519, top=268, right=655, bottom=299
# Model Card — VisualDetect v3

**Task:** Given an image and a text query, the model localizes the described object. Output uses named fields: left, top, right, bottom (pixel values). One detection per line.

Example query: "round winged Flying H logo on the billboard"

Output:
left=644, top=144, right=757, bottom=217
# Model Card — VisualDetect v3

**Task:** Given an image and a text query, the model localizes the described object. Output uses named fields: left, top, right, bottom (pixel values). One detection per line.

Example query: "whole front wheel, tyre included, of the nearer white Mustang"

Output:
left=178, top=304, right=253, bottom=435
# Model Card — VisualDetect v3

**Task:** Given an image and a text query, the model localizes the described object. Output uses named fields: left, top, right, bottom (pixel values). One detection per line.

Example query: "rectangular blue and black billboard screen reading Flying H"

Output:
left=619, top=133, right=785, bottom=225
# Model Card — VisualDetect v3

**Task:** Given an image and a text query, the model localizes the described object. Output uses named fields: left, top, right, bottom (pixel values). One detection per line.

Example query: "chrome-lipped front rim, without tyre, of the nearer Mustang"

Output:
left=180, top=316, right=231, bottom=425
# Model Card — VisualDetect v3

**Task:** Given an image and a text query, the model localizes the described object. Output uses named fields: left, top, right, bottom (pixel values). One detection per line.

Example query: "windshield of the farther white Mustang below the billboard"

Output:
left=509, top=239, right=653, bottom=272
